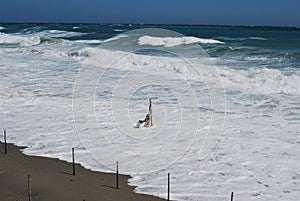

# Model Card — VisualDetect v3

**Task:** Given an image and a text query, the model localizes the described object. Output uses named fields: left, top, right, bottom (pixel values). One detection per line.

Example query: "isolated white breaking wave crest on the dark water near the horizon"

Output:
left=138, top=36, right=224, bottom=47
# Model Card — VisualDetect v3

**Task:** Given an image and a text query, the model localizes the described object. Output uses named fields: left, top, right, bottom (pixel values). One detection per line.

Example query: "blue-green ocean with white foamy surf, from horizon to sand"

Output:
left=0, top=24, right=300, bottom=201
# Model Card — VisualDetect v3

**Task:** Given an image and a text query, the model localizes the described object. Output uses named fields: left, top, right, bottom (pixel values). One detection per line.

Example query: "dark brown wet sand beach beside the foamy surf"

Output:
left=0, top=142, right=165, bottom=201
